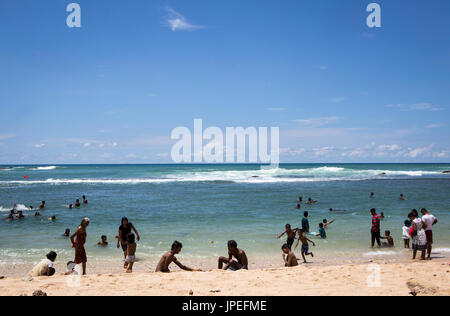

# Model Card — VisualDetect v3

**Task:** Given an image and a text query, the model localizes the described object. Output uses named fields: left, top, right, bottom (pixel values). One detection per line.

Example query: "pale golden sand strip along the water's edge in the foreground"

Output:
left=0, top=259, right=450, bottom=296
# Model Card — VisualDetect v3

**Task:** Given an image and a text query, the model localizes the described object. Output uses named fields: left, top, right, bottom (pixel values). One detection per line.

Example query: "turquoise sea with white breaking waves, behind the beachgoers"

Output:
left=0, top=164, right=450, bottom=264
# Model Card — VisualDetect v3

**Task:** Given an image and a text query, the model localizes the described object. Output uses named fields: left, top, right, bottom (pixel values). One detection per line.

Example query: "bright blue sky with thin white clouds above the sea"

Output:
left=0, top=0, right=450, bottom=164
